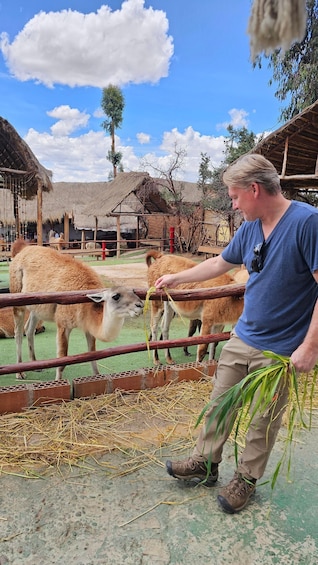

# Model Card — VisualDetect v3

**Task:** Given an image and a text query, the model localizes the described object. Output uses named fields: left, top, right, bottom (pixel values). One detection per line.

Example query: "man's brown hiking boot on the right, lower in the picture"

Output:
left=217, top=472, right=256, bottom=514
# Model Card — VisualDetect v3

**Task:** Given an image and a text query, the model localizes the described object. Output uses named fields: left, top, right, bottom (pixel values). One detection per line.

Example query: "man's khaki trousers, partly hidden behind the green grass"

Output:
left=193, top=332, right=288, bottom=479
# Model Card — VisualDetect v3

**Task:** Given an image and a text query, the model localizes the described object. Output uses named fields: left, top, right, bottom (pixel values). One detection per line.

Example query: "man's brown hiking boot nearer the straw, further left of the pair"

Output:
left=166, top=457, right=219, bottom=487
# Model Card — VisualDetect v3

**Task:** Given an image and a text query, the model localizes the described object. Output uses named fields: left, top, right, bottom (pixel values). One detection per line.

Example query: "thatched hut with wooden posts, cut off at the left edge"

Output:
left=0, top=117, right=52, bottom=241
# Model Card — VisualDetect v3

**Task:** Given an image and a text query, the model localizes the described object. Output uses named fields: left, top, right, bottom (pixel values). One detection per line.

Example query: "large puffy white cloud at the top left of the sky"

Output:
left=0, top=0, right=173, bottom=88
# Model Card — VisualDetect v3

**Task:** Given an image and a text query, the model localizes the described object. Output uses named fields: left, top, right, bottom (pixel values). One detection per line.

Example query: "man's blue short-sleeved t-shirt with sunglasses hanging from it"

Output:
left=222, top=201, right=318, bottom=356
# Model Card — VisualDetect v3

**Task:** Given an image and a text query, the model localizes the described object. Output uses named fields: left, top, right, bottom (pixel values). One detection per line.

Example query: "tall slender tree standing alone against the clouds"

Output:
left=101, top=84, right=125, bottom=178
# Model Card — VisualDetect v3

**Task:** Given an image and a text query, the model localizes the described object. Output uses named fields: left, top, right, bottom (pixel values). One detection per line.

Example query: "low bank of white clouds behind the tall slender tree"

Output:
left=24, top=116, right=231, bottom=182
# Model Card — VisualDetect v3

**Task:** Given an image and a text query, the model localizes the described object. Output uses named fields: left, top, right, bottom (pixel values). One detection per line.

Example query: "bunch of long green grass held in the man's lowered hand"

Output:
left=196, top=351, right=318, bottom=488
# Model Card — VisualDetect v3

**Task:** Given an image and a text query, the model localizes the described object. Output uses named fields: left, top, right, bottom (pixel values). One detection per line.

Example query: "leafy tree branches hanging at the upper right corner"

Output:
left=254, top=0, right=318, bottom=122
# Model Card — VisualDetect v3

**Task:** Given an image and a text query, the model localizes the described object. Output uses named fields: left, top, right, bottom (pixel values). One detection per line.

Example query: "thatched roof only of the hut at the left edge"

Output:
left=0, top=117, right=52, bottom=199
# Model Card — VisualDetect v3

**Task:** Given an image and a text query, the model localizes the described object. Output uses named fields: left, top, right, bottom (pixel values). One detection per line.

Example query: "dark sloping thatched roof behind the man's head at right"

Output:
left=251, top=100, right=318, bottom=191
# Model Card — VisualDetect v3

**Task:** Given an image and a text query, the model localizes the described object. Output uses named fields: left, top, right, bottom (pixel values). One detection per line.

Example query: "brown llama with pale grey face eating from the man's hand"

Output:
left=9, top=241, right=143, bottom=380
